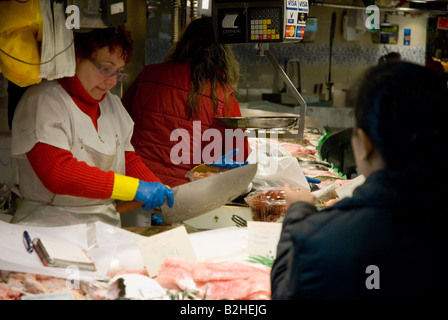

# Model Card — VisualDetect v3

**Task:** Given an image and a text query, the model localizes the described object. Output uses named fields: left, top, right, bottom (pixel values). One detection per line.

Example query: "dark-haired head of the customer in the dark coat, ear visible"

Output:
left=352, top=62, right=448, bottom=176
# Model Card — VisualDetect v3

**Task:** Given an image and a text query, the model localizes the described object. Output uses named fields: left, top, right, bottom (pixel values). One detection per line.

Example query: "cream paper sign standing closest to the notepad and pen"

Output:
left=137, top=226, right=197, bottom=277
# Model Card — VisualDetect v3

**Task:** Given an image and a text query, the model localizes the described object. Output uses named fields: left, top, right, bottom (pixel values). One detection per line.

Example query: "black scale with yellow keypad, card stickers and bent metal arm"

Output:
left=212, top=0, right=309, bottom=140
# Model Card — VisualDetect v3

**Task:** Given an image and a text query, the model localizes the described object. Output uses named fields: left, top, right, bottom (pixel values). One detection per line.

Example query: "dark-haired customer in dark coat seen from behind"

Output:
left=271, top=62, right=448, bottom=299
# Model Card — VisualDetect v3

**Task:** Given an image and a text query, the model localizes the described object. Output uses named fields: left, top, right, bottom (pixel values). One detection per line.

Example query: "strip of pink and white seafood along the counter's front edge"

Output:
left=0, top=257, right=271, bottom=300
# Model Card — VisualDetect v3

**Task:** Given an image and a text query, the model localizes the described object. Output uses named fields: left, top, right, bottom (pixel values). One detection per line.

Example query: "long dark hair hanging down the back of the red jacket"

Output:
left=165, top=17, right=239, bottom=117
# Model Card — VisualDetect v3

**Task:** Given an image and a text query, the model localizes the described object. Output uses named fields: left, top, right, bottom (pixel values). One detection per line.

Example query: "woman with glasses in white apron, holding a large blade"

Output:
left=11, top=27, right=173, bottom=226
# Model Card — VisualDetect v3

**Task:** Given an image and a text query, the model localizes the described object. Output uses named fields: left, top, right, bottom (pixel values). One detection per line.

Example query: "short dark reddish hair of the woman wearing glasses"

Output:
left=75, top=25, right=134, bottom=64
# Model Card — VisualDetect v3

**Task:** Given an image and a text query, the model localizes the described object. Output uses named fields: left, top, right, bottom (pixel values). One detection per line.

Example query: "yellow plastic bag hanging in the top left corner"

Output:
left=0, top=0, right=42, bottom=87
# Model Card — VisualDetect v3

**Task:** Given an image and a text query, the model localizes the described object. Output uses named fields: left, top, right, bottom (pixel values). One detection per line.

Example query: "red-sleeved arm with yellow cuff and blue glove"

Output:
left=27, top=143, right=173, bottom=209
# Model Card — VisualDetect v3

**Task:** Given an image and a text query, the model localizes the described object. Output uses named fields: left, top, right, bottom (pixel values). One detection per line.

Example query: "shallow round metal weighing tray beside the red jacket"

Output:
left=215, top=116, right=299, bottom=129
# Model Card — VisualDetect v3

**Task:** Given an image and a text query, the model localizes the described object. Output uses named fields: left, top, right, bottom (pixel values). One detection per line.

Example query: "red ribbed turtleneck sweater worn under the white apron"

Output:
left=27, top=76, right=160, bottom=199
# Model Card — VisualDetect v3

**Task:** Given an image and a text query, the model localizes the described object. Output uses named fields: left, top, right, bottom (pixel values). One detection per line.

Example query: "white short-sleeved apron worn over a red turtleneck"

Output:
left=11, top=81, right=134, bottom=226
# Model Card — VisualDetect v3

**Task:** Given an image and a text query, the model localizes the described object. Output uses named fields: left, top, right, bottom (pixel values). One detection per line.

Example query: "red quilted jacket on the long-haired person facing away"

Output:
left=122, top=62, right=249, bottom=187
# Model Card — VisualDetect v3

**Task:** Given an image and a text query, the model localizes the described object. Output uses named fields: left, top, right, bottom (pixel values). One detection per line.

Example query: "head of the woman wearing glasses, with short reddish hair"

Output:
left=75, top=26, right=133, bottom=100
